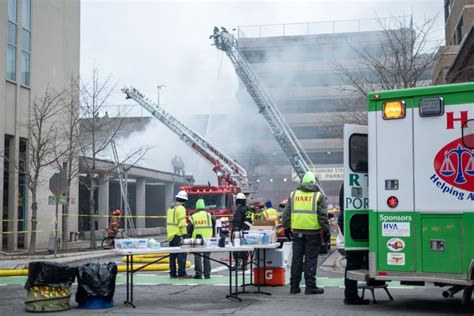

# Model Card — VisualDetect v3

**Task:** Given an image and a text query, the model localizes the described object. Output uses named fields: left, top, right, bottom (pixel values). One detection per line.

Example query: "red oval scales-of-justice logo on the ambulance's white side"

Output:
left=434, top=138, right=474, bottom=192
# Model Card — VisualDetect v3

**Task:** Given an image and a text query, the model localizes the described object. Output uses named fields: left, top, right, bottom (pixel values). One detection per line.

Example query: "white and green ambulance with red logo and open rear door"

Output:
left=344, top=83, right=474, bottom=303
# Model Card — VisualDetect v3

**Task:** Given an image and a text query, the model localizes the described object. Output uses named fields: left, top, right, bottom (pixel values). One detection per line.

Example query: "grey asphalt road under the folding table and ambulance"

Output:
left=0, top=251, right=474, bottom=316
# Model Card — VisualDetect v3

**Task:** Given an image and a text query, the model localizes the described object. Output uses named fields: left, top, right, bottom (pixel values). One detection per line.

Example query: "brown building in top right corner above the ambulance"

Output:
left=433, top=0, right=474, bottom=84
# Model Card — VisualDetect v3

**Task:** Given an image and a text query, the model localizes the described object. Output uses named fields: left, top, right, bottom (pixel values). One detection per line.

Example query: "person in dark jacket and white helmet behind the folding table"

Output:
left=231, top=193, right=253, bottom=270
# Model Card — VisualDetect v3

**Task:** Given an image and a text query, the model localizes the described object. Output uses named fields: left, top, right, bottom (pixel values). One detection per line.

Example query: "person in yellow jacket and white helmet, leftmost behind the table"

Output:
left=166, top=191, right=192, bottom=279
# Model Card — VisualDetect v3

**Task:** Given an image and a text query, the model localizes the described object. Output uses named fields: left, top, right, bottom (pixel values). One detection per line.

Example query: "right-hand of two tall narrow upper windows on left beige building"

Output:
left=21, top=0, right=31, bottom=86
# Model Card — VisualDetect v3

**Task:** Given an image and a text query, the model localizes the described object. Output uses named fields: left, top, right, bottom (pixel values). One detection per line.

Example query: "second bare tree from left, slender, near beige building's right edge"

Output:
left=56, top=75, right=81, bottom=249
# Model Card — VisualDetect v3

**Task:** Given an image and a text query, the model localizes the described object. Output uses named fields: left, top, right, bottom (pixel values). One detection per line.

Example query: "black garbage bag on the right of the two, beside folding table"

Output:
left=76, top=262, right=117, bottom=304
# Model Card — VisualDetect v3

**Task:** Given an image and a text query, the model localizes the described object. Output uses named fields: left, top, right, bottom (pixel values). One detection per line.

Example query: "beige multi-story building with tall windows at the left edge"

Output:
left=0, top=0, right=80, bottom=250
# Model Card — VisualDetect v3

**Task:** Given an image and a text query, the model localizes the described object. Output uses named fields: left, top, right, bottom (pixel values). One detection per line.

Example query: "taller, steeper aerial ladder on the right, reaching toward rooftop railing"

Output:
left=210, top=27, right=324, bottom=192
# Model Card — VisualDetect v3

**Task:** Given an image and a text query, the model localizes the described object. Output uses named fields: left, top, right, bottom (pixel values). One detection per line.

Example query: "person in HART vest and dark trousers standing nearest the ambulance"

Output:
left=283, top=171, right=329, bottom=294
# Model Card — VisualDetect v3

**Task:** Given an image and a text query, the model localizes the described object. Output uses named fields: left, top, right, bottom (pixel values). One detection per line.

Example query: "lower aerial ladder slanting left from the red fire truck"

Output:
left=122, top=87, right=248, bottom=187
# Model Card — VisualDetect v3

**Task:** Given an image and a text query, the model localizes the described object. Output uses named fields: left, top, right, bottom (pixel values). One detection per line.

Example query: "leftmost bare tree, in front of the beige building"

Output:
left=24, top=88, right=64, bottom=254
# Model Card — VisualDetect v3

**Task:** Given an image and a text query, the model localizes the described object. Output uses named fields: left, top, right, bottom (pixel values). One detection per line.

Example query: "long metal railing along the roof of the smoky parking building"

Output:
left=237, top=15, right=412, bottom=38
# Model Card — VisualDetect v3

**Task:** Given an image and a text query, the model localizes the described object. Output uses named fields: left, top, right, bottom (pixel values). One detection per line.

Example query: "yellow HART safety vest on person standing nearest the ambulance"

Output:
left=290, top=190, right=321, bottom=230
